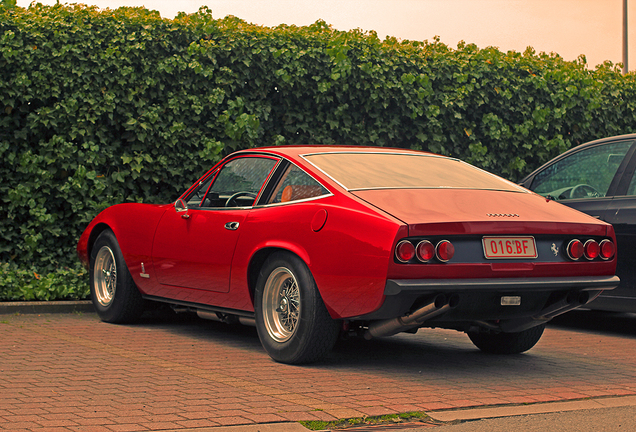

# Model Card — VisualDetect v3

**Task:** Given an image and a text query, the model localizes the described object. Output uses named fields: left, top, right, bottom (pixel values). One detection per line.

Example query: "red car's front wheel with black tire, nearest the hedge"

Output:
left=90, top=230, right=144, bottom=323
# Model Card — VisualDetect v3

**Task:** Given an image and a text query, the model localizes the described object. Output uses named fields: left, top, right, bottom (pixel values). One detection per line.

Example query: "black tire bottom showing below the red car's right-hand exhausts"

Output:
left=468, top=324, right=545, bottom=354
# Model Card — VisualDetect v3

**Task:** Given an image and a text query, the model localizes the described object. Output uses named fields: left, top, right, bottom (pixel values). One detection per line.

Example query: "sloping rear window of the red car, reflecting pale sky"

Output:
left=304, top=152, right=525, bottom=192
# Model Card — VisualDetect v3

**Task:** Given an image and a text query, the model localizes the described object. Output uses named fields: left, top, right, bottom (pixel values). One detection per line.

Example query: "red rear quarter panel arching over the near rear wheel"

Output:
left=231, top=196, right=400, bottom=318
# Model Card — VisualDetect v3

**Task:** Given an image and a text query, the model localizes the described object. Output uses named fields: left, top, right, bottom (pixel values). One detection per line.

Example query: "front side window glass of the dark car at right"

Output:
left=530, top=141, right=632, bottom=200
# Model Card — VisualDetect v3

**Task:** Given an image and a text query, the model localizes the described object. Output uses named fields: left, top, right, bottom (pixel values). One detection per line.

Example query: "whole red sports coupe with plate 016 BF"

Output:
left=77, top=146, right=619, bottom=363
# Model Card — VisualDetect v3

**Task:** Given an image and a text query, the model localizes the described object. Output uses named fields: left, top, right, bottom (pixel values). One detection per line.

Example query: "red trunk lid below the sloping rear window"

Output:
left=351, top=189, right=608, bottom=236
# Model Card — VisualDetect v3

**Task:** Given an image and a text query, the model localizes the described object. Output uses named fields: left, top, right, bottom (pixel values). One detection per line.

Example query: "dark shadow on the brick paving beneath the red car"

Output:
left=126, top=308, right=564, bottom=378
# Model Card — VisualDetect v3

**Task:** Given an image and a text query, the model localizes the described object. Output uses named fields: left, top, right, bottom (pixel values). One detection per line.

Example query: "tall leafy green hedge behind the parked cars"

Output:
left=0, top=4, right=636, bottom=300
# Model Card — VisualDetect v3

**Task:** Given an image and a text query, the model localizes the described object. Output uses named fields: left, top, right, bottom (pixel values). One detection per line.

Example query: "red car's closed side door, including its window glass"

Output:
left=152, top=156, right=279, bottom=292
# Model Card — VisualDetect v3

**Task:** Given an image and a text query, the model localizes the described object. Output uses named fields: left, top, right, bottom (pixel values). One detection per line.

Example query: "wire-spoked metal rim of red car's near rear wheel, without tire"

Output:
left=262, top=267, right=300, bottom=343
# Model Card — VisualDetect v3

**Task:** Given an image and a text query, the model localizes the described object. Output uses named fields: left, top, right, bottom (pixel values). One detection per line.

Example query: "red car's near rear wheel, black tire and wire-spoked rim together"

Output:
left=254, top=252, right=339, bottom=364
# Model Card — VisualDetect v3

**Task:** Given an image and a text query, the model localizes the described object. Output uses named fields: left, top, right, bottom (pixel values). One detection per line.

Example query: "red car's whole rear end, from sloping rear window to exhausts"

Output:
left=300, top=151, right=619, bottom=337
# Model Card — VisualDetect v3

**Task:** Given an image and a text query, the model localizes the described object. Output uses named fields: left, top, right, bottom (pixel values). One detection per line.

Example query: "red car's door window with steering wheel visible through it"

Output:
left=203, top=157, right=278, bottom=207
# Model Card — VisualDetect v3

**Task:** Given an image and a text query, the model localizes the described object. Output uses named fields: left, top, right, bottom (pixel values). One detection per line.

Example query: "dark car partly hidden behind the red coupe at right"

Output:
left=521, top=134, right=636, bottom=312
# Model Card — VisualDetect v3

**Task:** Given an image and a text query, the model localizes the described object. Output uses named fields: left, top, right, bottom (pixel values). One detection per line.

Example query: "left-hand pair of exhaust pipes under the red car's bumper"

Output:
left=364, top=294, right=459, bottom=340
